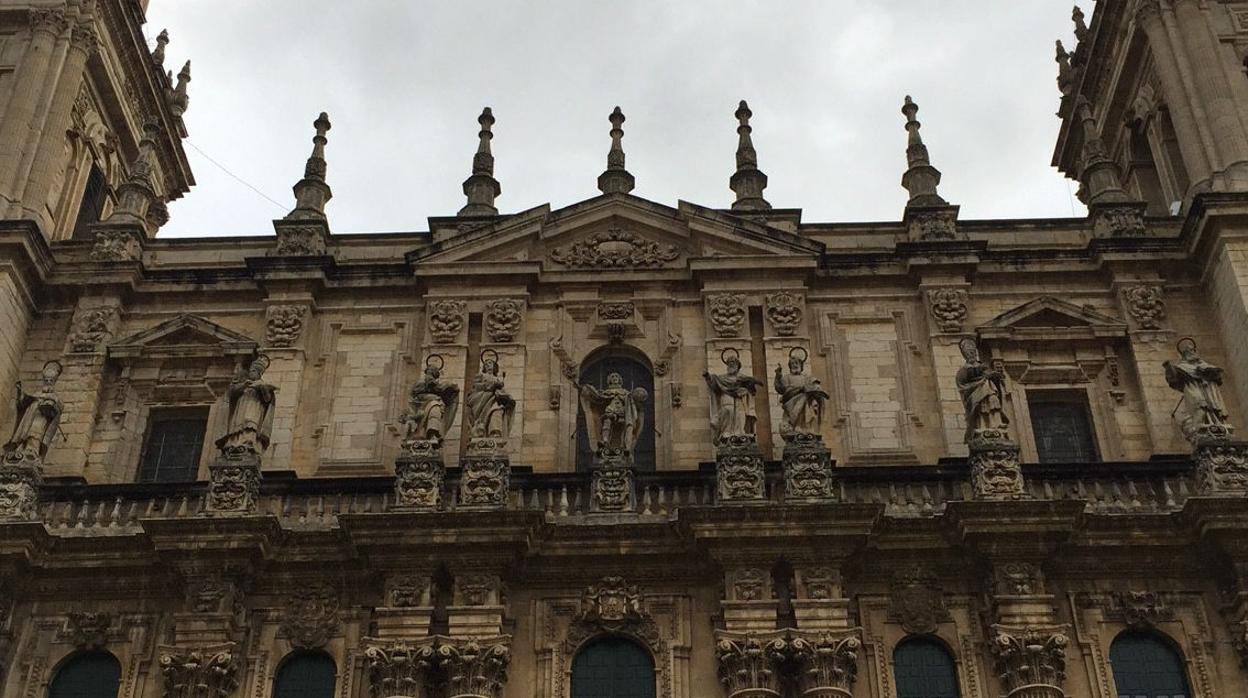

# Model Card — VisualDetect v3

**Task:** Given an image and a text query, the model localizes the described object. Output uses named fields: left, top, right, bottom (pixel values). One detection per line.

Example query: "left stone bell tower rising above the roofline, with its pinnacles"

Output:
left=0, top=0, right=195, bottom=241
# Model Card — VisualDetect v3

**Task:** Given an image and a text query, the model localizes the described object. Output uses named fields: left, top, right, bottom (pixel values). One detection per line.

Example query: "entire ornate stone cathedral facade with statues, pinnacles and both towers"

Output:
left=0, top=0, right=1248, bottom=698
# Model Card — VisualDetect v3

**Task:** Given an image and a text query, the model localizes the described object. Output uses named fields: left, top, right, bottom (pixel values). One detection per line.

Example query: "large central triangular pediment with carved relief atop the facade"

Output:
left=407, top=195, right=822, bottom=273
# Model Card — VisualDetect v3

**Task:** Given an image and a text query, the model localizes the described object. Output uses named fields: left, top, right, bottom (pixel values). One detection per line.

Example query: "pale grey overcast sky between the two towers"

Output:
left=146, top=0, right=1091, bottom=236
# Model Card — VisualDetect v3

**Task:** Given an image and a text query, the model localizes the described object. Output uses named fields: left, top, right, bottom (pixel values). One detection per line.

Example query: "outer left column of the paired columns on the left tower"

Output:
left=0, top=7, right=66, bottom=207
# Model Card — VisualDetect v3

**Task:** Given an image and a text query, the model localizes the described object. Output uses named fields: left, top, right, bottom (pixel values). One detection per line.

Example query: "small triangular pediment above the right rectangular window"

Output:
left=977, top=296, right=1127, bottom=341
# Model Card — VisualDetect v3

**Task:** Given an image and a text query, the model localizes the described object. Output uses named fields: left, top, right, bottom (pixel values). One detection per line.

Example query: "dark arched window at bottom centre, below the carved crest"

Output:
left=572, top=637, right=654, bottom=698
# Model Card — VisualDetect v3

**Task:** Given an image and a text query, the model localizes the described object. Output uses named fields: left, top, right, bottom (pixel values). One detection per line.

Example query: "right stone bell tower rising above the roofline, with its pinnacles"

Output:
left=1053, top=0, right=1248, bottom=215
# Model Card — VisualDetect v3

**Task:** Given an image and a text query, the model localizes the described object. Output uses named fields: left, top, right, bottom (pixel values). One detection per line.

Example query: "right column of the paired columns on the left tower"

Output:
left=21, top=19, right=97, bottom=231
